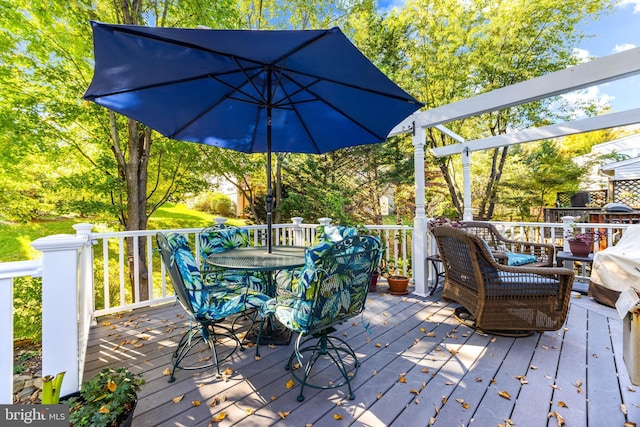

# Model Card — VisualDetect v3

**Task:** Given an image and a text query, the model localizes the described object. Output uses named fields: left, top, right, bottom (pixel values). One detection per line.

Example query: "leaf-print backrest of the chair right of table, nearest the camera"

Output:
left=297, top=235, right=381, bottom=334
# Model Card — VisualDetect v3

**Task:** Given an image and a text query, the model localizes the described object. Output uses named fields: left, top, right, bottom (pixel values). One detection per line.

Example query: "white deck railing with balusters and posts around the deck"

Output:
left=0, top=218, right=627, bottom=404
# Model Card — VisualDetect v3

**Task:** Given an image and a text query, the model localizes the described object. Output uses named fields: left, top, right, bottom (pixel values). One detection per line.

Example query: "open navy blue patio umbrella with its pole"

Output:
left=84, top=22, right=423, bottom=252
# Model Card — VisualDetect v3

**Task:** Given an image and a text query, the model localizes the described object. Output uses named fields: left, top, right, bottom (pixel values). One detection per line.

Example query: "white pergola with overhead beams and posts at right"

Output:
left=389, top=47, right=640, bottom=296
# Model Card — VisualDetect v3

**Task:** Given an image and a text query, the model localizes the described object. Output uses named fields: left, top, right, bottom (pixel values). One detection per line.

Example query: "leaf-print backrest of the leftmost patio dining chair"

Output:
left=156, top=233, right=204, bottom=314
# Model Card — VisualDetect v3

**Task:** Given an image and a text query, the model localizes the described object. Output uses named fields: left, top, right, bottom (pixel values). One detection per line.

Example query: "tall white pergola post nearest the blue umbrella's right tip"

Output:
left=411, top=124, right=429, bottom=297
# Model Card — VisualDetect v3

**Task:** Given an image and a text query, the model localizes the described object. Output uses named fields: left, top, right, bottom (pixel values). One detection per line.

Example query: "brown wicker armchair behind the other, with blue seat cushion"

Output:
left=459, top=221, right=555, bottom=267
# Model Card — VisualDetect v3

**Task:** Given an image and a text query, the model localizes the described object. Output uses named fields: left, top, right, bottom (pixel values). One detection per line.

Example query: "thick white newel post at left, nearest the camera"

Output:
left=31, top=235, right=87, bottom=396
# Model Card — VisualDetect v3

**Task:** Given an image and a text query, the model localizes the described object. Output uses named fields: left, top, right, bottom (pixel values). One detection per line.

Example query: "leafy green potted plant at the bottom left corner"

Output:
left=61, top=368, right=144, bottom=427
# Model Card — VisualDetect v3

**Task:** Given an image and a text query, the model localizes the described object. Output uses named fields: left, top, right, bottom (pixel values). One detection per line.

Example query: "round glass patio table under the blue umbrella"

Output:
left=207, top=246, right=307, bottom=345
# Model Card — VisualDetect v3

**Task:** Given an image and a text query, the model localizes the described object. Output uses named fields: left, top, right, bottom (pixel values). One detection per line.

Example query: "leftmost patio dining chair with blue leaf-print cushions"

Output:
left=156, top=233, right=269, bottom=382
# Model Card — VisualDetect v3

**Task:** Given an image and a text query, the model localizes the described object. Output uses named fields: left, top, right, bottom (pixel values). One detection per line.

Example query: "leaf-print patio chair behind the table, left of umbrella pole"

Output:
left=198, top=224, right=267, bottom=293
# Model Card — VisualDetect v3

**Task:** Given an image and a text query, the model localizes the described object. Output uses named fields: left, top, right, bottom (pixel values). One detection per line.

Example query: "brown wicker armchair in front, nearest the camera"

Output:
left=431, top=226, right=574, bottom=331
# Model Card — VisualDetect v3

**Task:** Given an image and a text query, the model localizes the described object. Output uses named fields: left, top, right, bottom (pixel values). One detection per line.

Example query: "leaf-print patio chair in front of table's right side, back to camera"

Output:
left=256, top=235, right=380, bottom=402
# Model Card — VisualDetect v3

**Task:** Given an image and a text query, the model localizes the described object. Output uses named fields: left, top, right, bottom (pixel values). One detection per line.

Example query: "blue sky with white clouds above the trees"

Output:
left=378, top=0, right=640, bottom=111
